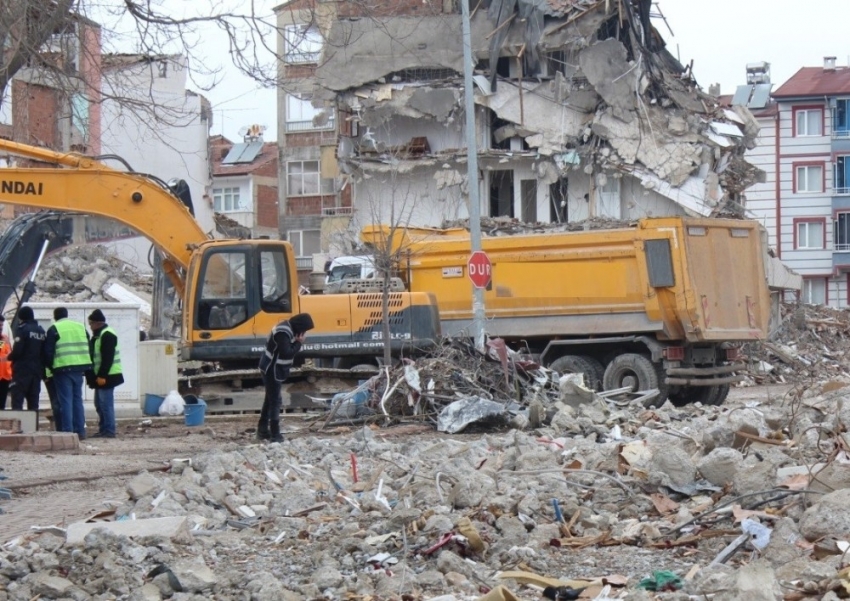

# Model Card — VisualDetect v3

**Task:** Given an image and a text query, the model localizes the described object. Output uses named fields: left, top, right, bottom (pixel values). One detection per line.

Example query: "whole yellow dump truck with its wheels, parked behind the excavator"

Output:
left=361, top=217, right=770, bottom=404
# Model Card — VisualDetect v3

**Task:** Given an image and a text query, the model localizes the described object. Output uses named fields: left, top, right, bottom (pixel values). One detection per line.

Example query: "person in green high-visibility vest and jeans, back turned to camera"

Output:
left=44, top=307, right=91, bottom=440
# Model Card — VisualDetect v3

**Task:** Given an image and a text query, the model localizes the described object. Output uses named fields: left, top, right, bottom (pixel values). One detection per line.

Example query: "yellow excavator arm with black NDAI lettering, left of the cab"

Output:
left=0, top=140, right=208, bottom=295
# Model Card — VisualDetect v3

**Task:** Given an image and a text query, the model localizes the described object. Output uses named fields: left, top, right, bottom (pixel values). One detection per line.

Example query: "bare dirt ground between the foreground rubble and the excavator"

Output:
left=0, top=385, right=791, bottom=544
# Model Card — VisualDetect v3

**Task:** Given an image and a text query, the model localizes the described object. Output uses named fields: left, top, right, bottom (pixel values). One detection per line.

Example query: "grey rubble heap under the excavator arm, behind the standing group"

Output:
left=26, top=245, right=152, bottom=302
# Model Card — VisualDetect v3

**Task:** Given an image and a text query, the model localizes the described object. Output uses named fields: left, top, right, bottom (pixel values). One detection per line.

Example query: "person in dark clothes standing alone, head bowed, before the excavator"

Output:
left=257, top=313, right=313, bottom=442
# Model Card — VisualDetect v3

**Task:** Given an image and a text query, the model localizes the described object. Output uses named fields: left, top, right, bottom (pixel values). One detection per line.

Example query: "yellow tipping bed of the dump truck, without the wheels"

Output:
left=362, top=217, right=769, bottom=342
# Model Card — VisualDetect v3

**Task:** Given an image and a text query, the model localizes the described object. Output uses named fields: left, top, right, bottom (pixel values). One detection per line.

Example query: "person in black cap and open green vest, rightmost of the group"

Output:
left=87, top=309, right=124, bottom=438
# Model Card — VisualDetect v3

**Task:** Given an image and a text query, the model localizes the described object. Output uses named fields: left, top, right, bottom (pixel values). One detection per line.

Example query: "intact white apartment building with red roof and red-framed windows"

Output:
left=745, top=57, right=850, bottom=307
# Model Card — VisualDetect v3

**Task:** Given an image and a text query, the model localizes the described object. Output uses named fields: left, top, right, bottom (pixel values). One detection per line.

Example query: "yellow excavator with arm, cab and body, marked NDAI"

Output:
left=0, top=140, right=440, bottom=369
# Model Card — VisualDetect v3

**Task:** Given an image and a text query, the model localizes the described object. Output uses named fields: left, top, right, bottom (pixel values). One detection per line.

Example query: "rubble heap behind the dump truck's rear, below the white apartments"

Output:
left=745, top=304, right=850, bottom=385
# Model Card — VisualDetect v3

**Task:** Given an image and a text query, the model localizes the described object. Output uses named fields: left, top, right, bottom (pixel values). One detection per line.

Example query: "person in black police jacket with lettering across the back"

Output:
left=9, top=307, right=45, bottom=411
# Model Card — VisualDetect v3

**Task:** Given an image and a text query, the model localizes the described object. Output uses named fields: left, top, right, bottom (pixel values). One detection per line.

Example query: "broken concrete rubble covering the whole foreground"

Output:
left=8, top=379, right=850, bottom=601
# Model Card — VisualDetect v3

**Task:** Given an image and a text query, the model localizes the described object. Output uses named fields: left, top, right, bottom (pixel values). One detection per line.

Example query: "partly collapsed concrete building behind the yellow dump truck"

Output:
left=277, top=0, right=761, bottom=248
